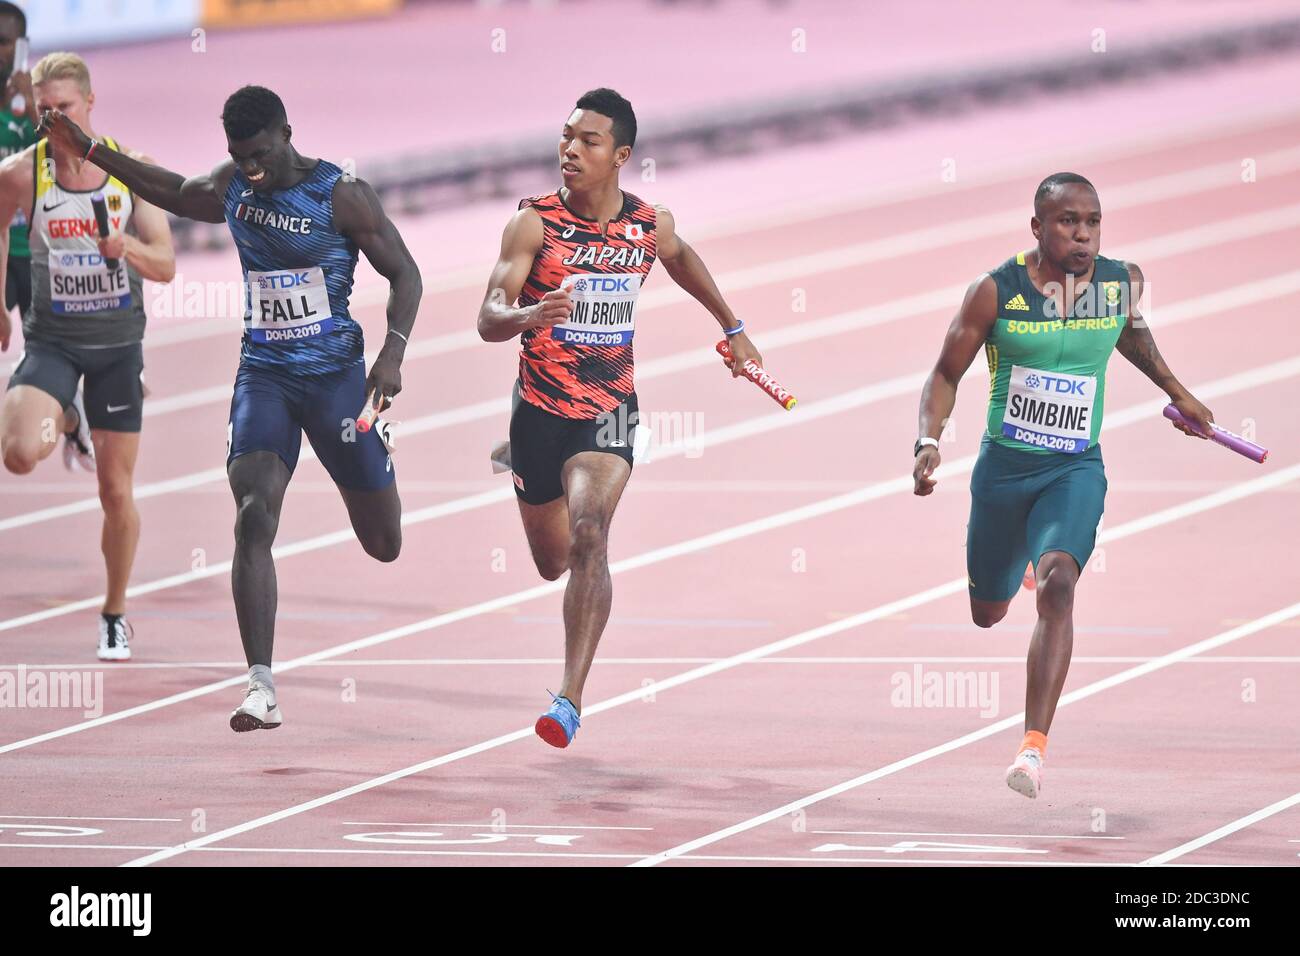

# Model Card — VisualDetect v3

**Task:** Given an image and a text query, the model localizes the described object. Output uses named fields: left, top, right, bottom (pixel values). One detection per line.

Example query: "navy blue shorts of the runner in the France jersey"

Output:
left=226, top=363, right=397, bottom=492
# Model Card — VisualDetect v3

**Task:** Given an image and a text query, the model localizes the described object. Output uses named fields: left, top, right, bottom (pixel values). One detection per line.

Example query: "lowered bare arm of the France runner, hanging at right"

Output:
left=334, top=179, right=424, bottom=411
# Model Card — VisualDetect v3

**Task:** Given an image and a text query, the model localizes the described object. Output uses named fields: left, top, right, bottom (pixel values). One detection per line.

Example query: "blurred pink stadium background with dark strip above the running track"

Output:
left=26, top=0, right=1300, bottom=248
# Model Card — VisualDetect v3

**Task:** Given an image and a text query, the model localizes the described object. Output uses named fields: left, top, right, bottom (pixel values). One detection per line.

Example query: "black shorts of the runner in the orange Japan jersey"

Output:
left=510, top=393, right=640, bottom=505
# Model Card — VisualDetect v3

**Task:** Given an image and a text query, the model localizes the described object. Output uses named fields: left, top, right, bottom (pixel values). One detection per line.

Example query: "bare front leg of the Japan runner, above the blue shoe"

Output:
left=559, top=451, right=632, bottom=711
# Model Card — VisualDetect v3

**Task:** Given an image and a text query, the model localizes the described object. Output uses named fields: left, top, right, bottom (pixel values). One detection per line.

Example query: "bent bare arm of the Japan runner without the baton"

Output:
left=478, top=207, right=573, bottom=342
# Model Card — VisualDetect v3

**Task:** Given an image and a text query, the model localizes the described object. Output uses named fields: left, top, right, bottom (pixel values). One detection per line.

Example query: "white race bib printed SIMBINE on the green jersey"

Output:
left=1002, top=365, right=1097, bottom=455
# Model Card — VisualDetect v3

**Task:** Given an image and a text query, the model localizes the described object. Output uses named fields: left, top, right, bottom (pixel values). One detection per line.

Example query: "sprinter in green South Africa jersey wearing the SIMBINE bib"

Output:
left=913, top=173, right=1214, bottom=797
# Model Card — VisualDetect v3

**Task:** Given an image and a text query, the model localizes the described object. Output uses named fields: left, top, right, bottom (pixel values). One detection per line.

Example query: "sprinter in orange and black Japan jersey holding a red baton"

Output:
left=478, top=90, right=762, bottom=747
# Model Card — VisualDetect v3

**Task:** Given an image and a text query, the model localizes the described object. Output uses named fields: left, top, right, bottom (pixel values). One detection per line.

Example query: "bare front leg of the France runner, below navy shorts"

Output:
left=226, top=451, right=291, bottom=667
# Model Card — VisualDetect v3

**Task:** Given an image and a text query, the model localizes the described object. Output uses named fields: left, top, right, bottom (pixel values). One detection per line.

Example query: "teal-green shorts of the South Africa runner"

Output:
left=966, top=436, right=1106, bottom=601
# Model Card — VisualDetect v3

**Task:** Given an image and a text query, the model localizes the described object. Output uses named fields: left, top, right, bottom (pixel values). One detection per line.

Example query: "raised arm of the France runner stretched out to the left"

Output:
left=38, top=109, right=235, bottom=222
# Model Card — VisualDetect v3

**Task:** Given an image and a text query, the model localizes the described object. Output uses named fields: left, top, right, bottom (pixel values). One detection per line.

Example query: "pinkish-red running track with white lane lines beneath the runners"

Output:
left=0, top=87, right=1300, bottom=866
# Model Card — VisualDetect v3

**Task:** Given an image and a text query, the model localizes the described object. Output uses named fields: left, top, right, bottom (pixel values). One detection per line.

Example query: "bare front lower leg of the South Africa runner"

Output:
left=1024, top=551, right=1079, bottom=734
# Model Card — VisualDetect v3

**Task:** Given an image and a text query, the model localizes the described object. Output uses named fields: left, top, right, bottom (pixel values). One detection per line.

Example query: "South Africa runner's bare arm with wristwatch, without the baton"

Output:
left=911, top=273, right=997, bottom=494
